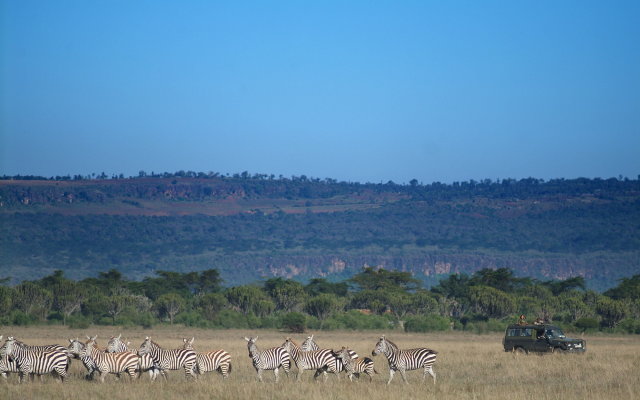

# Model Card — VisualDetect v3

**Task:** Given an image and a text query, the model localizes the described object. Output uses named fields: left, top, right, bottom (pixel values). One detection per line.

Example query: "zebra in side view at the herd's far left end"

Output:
left=0, top=336, right=69, bottom=383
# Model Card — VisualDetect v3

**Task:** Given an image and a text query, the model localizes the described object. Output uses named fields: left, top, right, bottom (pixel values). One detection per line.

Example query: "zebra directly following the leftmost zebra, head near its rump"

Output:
left=71, top=336, right=138, bottom=383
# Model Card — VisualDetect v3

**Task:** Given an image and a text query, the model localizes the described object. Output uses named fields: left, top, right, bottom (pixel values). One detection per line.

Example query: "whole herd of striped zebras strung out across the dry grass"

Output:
left=0, top=335, right=437, bottom=384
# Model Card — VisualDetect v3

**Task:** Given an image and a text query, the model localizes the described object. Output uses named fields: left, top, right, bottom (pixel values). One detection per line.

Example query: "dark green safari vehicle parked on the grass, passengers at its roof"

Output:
left=502, top=324, right=587, bottom=354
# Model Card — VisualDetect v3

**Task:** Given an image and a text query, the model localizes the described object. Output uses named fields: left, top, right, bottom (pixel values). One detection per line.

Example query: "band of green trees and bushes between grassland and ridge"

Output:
left=0, top=268, right=640, bottom=334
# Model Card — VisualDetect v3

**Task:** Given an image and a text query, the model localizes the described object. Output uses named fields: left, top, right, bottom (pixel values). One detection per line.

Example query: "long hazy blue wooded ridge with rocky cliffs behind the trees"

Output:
left=0, top=172, right=640, bottom=289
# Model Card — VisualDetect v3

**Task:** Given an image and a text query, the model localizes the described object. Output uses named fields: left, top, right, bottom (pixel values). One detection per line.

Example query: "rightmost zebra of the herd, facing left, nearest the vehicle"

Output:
left=371, top=335, right=438, bottom=385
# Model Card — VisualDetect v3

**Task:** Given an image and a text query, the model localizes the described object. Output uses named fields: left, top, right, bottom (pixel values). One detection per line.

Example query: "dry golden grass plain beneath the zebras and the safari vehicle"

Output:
left=0, top=326, right=640, bottom=400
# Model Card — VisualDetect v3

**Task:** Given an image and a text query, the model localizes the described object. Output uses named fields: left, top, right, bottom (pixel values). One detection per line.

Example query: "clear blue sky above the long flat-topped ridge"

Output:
left=0, top=0, right=640, bottom=183
